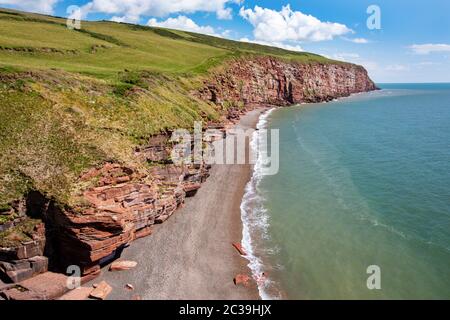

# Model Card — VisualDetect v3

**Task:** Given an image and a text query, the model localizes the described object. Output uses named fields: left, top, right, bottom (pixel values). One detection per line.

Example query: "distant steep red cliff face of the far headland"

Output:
left=200, top=57, right=376, bottom=106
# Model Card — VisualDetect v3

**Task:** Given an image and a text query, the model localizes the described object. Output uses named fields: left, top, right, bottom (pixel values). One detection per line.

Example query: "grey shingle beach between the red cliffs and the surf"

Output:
left=85, top=107, right=270, bottom=300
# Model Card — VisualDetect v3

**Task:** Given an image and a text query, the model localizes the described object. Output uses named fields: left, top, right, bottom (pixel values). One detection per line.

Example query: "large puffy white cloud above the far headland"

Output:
left=239, top=5, right=353, bottom=42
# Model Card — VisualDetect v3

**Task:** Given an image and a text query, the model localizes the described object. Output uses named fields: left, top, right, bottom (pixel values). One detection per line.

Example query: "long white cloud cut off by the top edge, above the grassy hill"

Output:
left=82, top=0, right=241, bottom=22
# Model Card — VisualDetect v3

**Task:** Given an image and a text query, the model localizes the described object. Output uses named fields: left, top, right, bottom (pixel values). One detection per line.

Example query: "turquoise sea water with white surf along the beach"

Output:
left=242, top=84, right=450, bottom=299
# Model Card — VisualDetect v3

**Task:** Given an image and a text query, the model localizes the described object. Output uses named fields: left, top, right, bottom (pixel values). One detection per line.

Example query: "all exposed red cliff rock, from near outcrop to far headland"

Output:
left=0, top=57, right=376, bottom=288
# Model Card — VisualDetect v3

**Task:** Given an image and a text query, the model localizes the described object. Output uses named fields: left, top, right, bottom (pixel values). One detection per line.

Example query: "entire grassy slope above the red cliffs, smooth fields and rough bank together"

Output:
left=0, top=9, right=338, bottom=210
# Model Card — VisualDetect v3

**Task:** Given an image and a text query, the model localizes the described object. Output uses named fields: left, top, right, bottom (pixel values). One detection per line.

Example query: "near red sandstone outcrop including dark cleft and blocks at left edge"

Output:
left=0, top=159, right=208, bottom=282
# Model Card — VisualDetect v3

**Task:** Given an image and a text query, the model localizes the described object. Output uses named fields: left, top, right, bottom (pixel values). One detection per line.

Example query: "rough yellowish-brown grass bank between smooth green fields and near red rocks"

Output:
left=0, top=71, right=220, bottom=204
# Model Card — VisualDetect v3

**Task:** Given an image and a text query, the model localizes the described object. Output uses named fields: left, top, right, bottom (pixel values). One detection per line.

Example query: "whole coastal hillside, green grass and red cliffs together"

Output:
left=0, top=9, right=375, bottom=288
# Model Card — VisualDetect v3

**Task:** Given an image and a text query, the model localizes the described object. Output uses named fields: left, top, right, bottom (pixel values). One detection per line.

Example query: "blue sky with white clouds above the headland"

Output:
left=0, top=0, right=450, bottom=83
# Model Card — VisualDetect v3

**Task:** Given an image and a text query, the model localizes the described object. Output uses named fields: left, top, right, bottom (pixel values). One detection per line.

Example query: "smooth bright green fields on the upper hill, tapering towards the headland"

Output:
left=0, top=9, right=338, bottom=81
